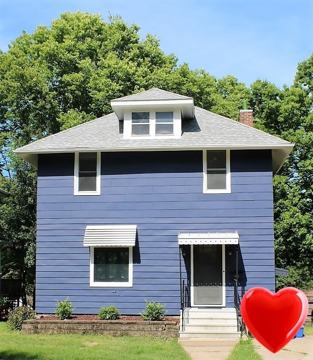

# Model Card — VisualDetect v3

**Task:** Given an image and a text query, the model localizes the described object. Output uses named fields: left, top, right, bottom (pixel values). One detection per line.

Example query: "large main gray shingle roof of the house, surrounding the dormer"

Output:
left=15, top=107, right=293, bottom=172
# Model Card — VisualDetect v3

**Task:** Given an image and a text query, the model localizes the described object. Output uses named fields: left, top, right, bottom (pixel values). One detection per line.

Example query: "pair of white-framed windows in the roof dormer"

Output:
left=124, top=111, right=177, bottom=138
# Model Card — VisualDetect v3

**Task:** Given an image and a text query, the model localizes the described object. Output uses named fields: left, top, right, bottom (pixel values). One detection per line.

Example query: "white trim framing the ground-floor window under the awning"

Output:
left=89, top=246, right=133, bottom=287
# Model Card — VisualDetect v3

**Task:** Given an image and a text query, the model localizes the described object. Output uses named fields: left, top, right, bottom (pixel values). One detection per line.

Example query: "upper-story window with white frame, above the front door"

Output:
left=203, top=150, right=231, bottom=193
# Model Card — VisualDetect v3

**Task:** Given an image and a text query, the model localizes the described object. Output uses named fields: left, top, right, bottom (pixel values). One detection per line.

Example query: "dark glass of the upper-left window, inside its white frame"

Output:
left=78, top=153, right=97, bottom=191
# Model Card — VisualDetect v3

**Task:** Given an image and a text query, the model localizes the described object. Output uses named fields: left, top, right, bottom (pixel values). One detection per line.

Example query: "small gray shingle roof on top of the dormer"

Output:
left=112, top=88, right=192, bottom=102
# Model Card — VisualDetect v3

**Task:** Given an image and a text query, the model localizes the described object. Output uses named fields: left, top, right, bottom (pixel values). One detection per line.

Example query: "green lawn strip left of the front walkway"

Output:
left=0, top=323, right=189, bottom=360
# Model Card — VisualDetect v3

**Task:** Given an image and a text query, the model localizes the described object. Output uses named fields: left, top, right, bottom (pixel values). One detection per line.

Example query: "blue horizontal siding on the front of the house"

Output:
left=36, top=151, right=275, bottom=314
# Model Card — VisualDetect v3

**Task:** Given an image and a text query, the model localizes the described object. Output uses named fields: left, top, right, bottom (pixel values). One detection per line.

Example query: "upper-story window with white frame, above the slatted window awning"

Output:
left=74, top=152, right=101, bottom=195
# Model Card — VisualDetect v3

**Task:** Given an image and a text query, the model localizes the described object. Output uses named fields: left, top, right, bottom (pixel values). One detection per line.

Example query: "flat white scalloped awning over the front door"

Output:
left=178, top=232, right=239, bottom=245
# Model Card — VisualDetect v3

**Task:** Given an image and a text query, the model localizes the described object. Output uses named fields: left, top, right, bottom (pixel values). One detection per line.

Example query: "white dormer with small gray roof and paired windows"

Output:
left=111, top=88, right=194, bottom=139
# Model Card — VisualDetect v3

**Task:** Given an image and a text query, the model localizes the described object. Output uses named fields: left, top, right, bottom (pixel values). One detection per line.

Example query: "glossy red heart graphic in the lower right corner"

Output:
left=240, top=287, right=308, bottom=353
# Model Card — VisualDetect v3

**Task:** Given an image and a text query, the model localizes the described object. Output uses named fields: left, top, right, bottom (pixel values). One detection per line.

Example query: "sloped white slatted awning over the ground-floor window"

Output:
left=84, top=225, right=137, bottom=247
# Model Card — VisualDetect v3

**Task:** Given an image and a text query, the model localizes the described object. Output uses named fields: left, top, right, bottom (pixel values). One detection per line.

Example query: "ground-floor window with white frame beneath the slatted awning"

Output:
left=90, top=247, right=133, bottom=287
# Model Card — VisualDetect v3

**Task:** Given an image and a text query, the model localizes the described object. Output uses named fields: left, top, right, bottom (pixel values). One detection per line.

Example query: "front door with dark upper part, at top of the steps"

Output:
left=191, top=245, right=225, bottom=306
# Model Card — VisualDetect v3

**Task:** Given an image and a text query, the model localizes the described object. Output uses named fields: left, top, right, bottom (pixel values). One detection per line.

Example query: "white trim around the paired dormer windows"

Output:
left=123, top=109, right=182, bottom=140
